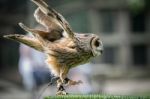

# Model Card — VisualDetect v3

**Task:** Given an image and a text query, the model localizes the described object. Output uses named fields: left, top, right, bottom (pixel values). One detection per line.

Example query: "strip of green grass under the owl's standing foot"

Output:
left=44, top=94, right=150, bottom=99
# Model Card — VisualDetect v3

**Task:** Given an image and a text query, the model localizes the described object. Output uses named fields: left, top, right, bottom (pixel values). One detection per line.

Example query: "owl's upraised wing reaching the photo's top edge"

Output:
left=32, top=0, right=74, bottom=38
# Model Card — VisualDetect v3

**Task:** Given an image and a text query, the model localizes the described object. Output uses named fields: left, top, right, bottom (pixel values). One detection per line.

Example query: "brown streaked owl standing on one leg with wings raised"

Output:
left=4, top=0, right=103, bottom=95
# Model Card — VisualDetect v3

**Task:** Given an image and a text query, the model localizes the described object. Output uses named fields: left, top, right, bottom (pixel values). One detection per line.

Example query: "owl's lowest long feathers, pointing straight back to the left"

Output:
left=4, top=34, right=44, bottom=52
